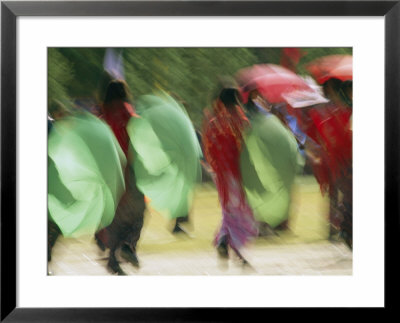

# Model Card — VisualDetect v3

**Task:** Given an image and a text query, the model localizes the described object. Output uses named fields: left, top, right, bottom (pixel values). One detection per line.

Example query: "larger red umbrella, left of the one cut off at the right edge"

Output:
left=237, top=64, right=313, bottom=103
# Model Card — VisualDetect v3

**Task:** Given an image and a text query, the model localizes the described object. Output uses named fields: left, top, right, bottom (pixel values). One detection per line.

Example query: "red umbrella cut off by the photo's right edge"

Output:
left=306, top=55, right=353, bottom=84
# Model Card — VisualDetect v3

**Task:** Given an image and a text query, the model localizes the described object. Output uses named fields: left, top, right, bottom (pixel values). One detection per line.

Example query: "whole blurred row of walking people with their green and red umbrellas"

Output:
left=48, top=48, right=353, bottom=275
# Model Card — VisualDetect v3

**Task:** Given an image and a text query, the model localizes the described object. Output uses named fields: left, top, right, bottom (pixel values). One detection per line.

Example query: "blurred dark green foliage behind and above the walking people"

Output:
left=48, top=48, right=352, bottom=127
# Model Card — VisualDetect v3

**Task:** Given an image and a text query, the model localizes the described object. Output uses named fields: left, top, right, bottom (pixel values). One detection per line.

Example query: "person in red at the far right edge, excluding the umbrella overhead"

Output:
left=287, top=78, right=352, bottom=248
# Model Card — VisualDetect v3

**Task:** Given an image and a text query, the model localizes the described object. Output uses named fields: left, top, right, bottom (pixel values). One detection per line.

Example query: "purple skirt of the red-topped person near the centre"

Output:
left=214, top=176, right=258, bottom=252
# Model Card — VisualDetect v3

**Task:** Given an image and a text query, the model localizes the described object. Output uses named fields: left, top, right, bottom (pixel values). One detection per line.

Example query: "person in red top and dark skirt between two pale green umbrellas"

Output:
left=95, top=80, right=146, bottom=275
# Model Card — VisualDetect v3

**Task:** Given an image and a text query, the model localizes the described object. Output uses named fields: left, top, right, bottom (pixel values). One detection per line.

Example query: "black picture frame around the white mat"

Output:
left=1, top=0, right=400, bottom=322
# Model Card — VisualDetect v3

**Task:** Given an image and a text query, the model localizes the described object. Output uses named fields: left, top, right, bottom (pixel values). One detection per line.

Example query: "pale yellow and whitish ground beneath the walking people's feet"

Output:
left=49, top=178, right=353, bottom=275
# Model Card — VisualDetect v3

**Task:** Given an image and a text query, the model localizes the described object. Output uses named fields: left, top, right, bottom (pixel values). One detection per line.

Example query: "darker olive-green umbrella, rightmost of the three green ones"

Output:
left=240, top=113, right=304, bottom=228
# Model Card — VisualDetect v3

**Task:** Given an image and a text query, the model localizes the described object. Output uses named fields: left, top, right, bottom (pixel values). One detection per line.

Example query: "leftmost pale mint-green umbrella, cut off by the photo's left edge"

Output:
left=48, top=113, right=126, bottom=237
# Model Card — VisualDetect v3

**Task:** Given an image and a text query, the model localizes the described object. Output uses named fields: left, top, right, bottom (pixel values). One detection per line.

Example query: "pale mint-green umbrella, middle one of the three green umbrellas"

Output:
left=127, top=94, right=202, bottom=219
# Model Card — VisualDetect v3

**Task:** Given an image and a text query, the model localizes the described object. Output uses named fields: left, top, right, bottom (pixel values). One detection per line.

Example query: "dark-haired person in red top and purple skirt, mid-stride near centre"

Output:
left=203, top=79, right=257, bottom=264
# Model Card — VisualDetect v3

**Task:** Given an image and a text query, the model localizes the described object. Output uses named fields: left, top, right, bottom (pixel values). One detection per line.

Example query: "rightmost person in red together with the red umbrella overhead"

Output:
left=306, top=55, right=353, bottom=248
